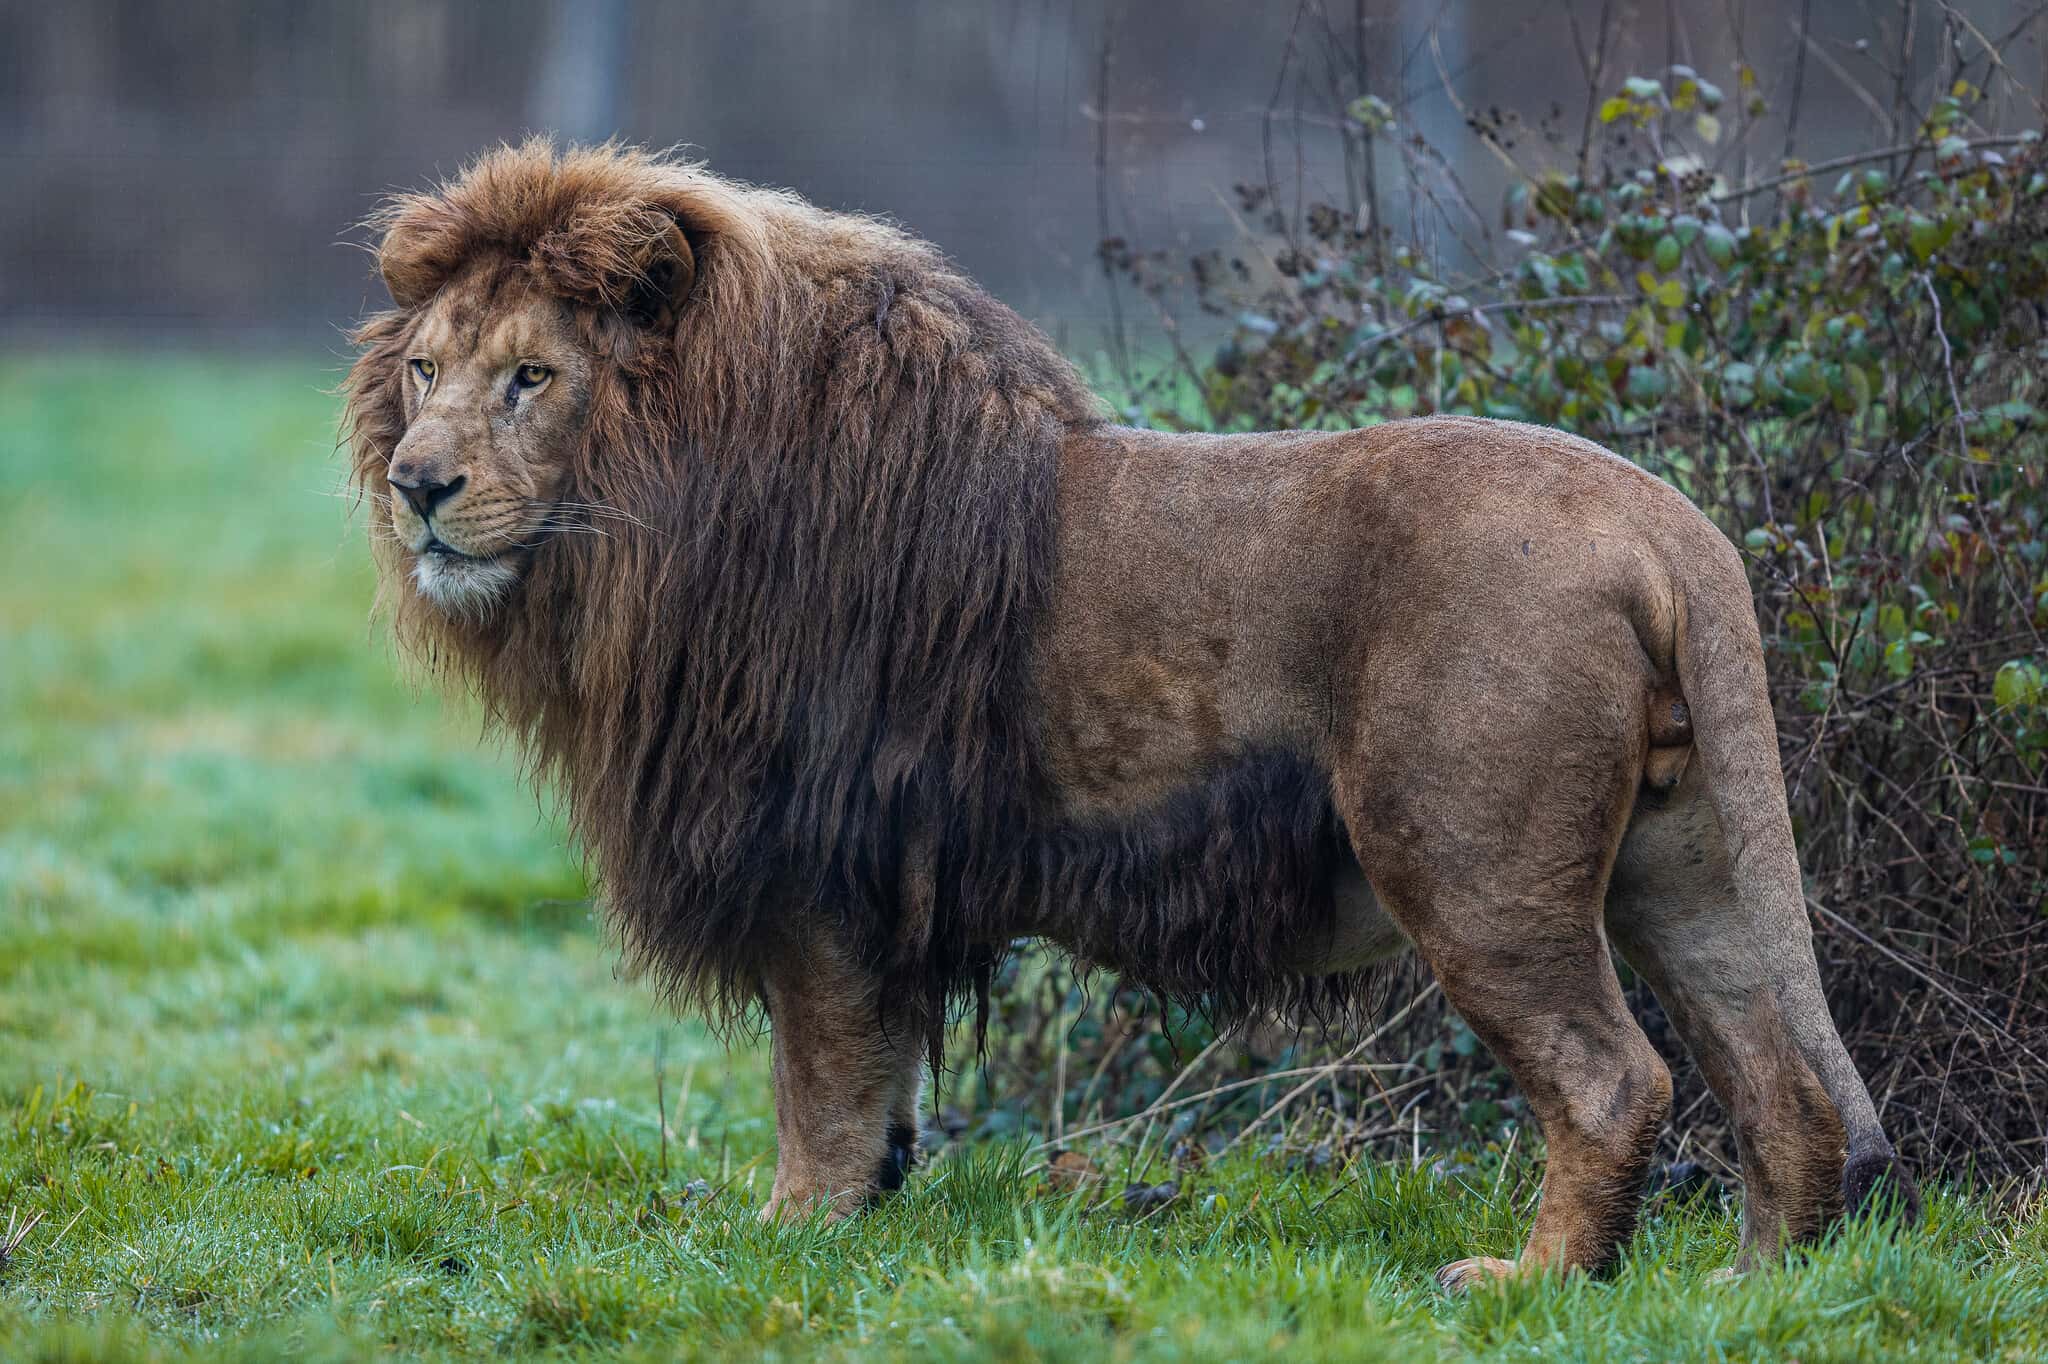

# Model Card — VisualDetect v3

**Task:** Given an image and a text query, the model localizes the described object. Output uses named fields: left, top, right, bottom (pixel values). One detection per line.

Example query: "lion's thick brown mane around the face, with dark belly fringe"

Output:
left=346, top=143, right=1346, bottom=1040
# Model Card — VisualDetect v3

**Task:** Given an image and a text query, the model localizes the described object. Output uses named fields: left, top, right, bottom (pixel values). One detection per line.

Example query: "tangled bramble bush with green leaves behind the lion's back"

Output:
left=978, top=68, right=2048, bottom=1176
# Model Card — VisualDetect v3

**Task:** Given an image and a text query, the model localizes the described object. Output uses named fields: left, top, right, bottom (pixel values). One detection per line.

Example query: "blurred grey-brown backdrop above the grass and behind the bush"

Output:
left=0, top=0, right=2044, bottom=348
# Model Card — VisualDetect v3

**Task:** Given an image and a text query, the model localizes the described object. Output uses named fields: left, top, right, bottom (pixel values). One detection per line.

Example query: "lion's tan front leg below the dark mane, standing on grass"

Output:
left=762, top=926, right=924, bottom=1219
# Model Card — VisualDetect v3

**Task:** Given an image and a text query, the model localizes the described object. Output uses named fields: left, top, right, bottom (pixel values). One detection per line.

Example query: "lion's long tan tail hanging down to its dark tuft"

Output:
left=1673, top=518, right=1919, bottom=1217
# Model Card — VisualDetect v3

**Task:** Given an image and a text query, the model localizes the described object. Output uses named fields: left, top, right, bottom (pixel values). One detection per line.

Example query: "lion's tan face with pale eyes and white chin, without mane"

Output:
left=385, top=270, right=590, bottom=619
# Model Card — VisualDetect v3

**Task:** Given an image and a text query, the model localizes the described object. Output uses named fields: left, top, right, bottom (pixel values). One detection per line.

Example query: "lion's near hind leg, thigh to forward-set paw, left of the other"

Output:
left=1339, top=659, right=1671, bottom=1286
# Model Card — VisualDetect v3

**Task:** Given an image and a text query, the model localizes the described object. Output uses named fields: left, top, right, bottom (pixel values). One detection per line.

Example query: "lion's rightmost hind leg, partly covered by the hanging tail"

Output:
left=1608, top=764, right=1843, bottom=1268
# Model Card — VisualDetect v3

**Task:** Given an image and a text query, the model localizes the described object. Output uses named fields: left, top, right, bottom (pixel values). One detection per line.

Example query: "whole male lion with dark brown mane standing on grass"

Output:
left=346, top=141, right=1915, bottom=1284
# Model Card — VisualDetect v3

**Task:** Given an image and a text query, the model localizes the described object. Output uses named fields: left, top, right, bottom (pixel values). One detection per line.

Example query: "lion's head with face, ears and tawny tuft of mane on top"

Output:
left=348, top=143, right=750, bottom=627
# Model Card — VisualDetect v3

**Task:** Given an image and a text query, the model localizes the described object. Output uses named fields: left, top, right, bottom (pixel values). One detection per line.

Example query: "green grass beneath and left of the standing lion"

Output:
left=0, top=356, right=2048, bottom=1360
